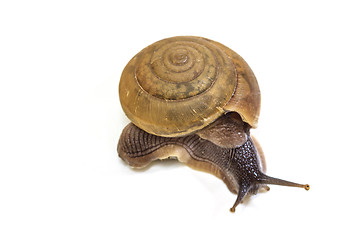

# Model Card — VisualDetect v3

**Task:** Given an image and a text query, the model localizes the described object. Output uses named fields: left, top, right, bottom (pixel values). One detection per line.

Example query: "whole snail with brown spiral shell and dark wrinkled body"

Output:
left=117, top=36, right=310, bottom=212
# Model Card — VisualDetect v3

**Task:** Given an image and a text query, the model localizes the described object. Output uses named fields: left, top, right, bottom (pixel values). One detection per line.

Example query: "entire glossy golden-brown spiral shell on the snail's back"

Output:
left=119, top=36, right=260, bottom=137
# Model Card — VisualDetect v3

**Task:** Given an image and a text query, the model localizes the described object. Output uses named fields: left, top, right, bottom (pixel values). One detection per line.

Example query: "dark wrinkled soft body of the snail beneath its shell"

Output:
left=118, top=115, right=310, bottom=211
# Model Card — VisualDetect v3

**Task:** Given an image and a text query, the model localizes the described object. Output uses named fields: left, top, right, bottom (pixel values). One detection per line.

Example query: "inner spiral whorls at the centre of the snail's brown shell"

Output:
left=135, top=40, right=219, bottom=100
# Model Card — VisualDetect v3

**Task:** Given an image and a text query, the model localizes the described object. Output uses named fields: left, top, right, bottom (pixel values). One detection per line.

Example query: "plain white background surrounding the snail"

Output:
left=0, top=0, right=360, bottom=239
